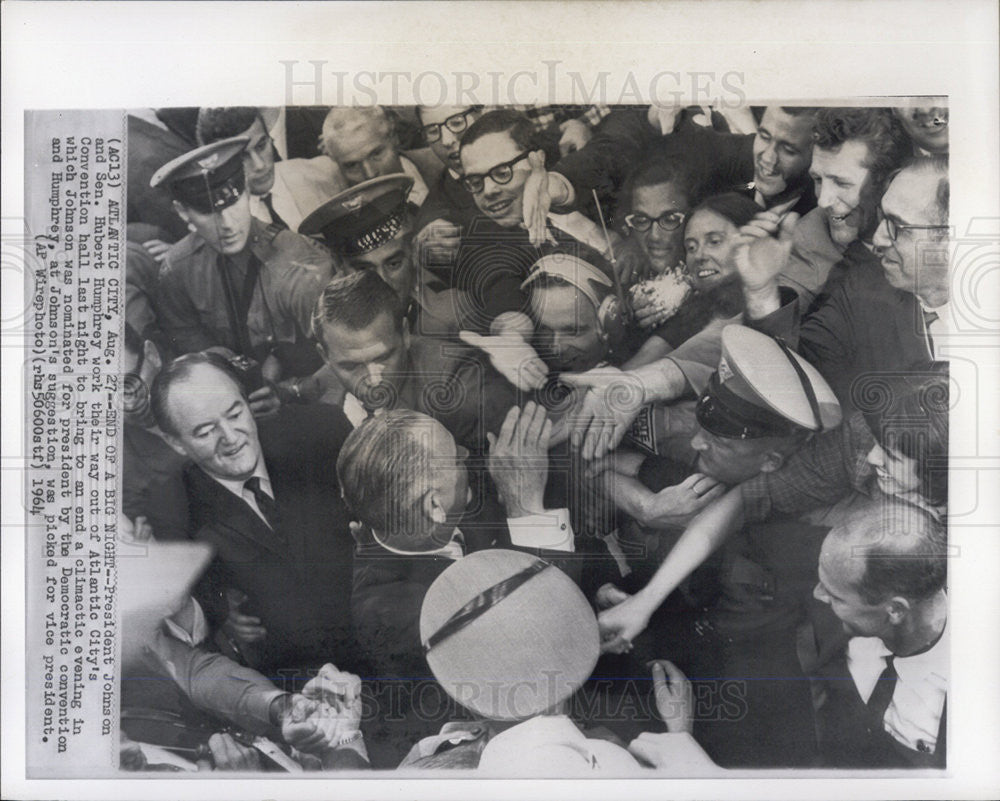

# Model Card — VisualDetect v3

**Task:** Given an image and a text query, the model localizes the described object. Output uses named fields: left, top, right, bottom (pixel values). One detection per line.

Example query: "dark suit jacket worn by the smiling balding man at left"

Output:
left=185, top=404, right=364, bottom=675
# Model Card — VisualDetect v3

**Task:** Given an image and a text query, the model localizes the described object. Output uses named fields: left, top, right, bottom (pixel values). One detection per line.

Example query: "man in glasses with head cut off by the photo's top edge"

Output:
left=414, top=106, right=483, bottom=265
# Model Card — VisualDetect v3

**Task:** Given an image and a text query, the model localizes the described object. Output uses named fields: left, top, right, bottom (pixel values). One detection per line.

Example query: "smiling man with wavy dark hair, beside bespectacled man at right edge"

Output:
left=782, top=108, right=909, bottom=309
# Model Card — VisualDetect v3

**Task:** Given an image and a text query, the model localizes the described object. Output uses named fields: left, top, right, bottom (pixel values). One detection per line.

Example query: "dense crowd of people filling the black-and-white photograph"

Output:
left=119, top=100, right=950, bottom=776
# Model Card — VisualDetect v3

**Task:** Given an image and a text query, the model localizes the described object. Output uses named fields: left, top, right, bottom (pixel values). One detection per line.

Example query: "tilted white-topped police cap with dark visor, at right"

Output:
left=697, top=325, right=841, bottom=439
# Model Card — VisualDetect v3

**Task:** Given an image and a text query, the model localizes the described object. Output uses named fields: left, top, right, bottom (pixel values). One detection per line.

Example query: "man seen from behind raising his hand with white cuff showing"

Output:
left=337, top=402, right=580, bottom=766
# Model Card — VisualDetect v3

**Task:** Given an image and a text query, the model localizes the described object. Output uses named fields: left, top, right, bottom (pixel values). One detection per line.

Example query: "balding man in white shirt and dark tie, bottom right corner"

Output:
left=815, top=504, right=949, bottom=768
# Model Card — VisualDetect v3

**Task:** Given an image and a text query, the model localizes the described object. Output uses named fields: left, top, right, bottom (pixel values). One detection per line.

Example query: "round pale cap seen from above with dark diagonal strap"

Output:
left=420, top=548, right=600, bottom=720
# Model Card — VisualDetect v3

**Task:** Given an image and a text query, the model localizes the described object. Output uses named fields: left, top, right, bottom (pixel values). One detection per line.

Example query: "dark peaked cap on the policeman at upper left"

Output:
left=149, top=136, right=250, bottom=214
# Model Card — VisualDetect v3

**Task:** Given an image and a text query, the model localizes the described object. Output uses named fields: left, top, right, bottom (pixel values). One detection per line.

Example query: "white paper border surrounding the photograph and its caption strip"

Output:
left=0, top=0, right=1000, bottom=799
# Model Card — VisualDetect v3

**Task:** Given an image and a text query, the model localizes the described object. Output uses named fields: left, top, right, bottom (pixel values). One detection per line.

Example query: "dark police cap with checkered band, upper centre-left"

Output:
left=299, top=173, right=413, bottom=256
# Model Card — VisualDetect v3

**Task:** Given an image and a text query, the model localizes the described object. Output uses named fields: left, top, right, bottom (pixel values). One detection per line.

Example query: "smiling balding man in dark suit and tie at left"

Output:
left=152, top=353, right=362, bottom=675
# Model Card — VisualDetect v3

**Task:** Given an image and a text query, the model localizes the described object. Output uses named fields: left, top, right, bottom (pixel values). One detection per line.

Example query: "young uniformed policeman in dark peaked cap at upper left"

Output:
left=152, top=137, right=332, bottom=405
